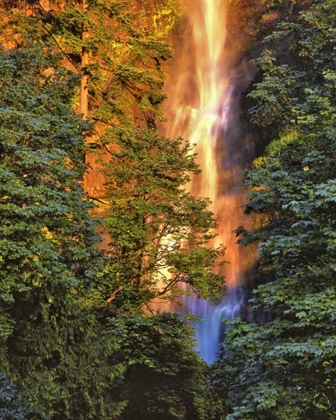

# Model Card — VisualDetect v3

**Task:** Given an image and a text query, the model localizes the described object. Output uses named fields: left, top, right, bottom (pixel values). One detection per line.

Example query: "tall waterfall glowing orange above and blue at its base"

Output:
left=167, top=0, right=253, bottom=363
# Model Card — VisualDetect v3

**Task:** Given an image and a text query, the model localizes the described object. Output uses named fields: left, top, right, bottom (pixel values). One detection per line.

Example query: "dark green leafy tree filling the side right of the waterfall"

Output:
left=214, top=1, right=336, bottom=420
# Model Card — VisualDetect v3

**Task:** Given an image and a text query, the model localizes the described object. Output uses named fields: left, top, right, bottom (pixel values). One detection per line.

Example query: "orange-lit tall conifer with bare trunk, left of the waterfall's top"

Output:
left=2, top=0, right=177, bottom=129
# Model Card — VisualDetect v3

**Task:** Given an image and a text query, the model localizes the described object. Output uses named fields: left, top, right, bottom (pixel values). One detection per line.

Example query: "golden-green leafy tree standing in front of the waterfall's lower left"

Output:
left=98, top=126, right=227, bottom=307
